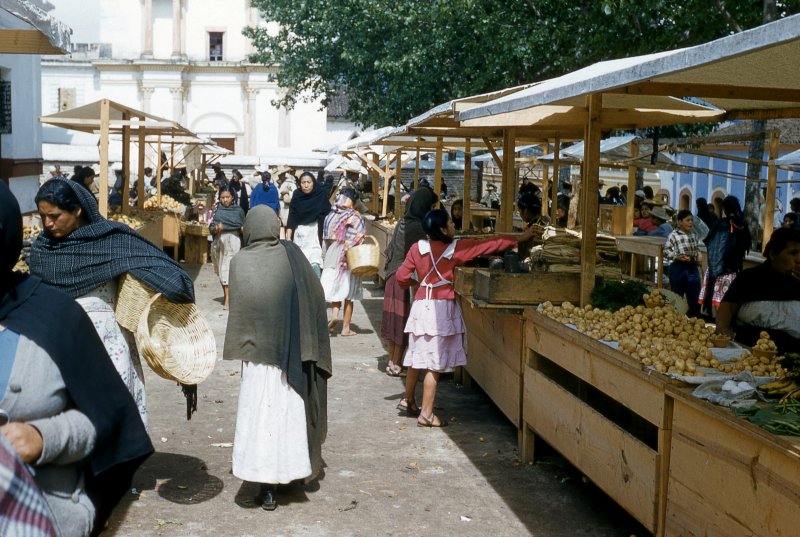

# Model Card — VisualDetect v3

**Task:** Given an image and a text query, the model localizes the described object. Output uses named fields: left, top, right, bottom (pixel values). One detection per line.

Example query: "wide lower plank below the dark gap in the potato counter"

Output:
left=523, top=368, right=660, bottom=532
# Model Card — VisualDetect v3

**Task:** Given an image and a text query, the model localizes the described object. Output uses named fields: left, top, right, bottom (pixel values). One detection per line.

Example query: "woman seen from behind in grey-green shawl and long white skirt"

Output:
left=223, top=205, right=331, bottom=511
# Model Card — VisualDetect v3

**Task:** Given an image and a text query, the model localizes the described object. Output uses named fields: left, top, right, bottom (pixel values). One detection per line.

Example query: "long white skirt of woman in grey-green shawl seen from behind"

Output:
left=233, top=362, right=311, bottom=484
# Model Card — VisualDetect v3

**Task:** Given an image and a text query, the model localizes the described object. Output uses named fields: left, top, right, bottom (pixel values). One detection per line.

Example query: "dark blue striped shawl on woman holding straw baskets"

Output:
left=29, top=179, right=194, bottom=303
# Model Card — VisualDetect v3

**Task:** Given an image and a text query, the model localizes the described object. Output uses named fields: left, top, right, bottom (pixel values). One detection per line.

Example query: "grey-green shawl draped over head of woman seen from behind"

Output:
left=223, top=206, right=332, bottom=481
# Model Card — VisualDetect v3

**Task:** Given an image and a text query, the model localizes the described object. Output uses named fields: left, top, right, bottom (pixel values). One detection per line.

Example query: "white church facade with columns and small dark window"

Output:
left=42, top=0, right=356, bottom=164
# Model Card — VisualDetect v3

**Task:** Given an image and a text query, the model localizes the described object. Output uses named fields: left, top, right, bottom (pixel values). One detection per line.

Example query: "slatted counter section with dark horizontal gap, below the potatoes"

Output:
left=522, top=308, right=672, bottom=535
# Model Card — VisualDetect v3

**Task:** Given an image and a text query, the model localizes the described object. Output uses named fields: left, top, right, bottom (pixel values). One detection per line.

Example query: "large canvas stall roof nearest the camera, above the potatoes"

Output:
left=457, top=15, right=800, bottom=125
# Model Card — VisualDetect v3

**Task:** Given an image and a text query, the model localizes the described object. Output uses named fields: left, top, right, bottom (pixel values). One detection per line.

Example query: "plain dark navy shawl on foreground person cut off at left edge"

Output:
left=0, top=179, right=153, bottom=524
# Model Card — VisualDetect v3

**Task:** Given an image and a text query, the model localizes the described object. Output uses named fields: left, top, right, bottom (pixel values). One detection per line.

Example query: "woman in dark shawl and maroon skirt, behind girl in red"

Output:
left=381, top=188, right=438, bottom=376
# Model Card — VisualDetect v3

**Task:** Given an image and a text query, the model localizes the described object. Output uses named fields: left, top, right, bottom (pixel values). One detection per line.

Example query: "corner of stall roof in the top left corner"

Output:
left=0, top=0, right=72, bottom=54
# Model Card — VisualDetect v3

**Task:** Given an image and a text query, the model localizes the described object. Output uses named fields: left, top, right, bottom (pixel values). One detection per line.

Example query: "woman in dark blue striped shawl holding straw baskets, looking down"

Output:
left=29, top=179, right=194, bottom=425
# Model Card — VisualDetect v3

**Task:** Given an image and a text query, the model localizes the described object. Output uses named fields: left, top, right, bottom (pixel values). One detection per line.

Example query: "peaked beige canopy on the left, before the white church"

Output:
left=39, top=99, right=196, bottom=137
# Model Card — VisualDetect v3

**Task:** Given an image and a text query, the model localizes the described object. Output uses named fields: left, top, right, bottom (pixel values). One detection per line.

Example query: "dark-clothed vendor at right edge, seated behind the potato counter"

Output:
left=716, top=228, right=800, bottom=354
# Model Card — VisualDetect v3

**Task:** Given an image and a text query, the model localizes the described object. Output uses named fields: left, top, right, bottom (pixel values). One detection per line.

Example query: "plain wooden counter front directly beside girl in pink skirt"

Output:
left=461, top=298, right=524, bottom=428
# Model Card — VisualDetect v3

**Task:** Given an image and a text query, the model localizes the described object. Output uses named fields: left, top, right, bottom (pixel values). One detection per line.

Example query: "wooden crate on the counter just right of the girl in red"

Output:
left=474, top=269, right=580, bottom=304
